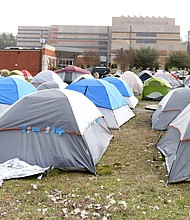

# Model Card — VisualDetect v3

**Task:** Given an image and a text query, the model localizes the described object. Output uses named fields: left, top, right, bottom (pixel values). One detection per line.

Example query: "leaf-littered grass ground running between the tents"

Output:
left=0, top=101, right=190, bottom=220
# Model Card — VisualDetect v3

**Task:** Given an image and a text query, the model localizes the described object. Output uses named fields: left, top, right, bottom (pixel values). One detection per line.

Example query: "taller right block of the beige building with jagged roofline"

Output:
left=111, top=16, right=187, bottom=68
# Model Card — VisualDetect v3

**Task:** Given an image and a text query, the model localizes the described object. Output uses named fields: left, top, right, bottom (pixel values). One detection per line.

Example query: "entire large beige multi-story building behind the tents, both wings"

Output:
left=17, top=16, right=187, bottom=68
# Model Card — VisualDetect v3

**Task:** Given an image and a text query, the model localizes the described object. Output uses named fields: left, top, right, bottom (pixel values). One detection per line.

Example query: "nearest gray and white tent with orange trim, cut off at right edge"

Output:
left=157, top=104, right=190, bottom=183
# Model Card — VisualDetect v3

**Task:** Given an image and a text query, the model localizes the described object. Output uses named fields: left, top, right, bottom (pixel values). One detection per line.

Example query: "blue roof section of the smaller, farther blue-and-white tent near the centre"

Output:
left=103, top=76, right=134, bottom=97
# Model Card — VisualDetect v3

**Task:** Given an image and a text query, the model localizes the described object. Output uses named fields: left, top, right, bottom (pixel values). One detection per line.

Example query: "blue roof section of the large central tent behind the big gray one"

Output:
left=66, top=79, right=127, bottom=110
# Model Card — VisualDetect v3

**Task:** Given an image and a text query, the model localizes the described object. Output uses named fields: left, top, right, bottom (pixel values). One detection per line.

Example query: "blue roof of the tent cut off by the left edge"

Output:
left=0, top=77, right=37, bottom=105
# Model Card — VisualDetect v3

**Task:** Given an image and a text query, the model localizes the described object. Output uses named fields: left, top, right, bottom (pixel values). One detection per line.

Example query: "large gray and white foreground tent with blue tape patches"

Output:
left=0, top=89, right=112, bottom=173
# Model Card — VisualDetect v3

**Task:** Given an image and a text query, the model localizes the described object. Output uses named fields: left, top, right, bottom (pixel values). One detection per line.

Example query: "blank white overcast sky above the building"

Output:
left=0, top=0, right=190, bottom=39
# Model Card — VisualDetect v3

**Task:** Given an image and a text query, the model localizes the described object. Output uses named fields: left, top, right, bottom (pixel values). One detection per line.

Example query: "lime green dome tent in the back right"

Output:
left=142, top=77, right=172, bottom=101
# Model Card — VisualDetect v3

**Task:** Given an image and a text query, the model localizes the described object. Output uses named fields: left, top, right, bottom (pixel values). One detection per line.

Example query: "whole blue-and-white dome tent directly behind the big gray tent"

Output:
left=66, top=79, right=135, bottom=129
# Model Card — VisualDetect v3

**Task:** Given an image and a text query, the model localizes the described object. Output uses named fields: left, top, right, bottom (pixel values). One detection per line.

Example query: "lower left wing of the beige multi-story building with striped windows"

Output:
left=17, top=25, right=111, bottom=66
